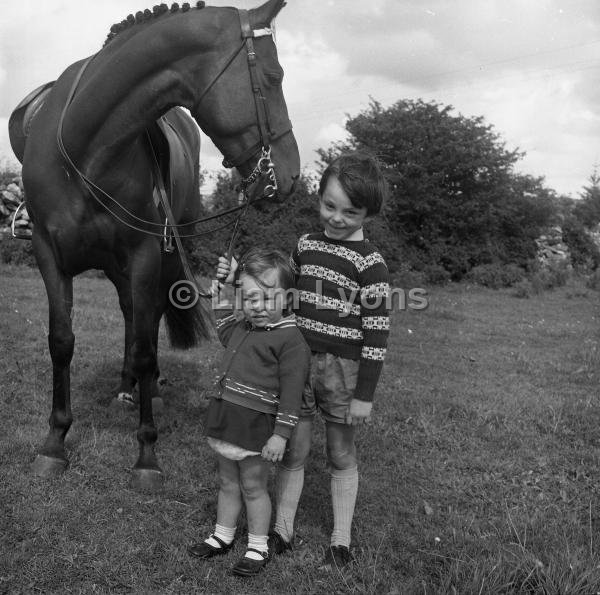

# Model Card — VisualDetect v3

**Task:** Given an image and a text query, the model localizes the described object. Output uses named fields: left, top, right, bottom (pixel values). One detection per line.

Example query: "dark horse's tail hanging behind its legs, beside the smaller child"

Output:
left=164, top=252, right=215, bottom=349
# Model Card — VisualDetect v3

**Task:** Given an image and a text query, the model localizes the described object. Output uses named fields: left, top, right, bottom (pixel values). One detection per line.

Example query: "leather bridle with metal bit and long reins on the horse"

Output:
left=56, top=9, right=291, bottom=237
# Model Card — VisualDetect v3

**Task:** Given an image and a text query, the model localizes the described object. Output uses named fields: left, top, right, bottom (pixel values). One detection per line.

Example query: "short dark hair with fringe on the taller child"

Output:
left=319, top=151, right=389, bottom=215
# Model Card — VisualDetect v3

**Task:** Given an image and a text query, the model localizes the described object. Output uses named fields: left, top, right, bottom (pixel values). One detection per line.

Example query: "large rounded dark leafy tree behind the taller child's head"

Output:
left=319, top=100, right=555, bottom=279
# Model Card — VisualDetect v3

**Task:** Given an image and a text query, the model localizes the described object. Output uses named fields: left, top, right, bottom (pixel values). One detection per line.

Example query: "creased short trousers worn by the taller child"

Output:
left=300, top=352, right=359, bottom=424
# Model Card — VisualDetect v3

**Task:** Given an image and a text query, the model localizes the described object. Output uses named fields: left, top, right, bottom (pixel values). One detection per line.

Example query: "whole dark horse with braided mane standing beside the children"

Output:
left=11, top=0, right=300, bottom=488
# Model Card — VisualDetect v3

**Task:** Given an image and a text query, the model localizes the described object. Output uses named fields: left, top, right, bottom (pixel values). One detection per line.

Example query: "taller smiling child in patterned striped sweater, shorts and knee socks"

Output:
left=218, top=152, right=390, bottom=569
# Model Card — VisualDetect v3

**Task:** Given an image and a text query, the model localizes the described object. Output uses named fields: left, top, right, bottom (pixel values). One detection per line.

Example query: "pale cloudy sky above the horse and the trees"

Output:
left=0, top=0, right=600, bottom=198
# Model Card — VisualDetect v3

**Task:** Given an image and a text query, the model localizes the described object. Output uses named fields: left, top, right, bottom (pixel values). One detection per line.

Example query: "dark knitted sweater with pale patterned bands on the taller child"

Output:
left=291, top=232, right=390, bottom=401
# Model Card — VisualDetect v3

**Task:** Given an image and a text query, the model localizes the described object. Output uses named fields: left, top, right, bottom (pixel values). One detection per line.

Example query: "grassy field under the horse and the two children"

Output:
left=0, top=267, right=600, bottom=595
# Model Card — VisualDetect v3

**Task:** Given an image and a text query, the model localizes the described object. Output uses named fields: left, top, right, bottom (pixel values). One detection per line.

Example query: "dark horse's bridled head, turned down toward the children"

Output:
left=192, top=0, right=300, bottom=201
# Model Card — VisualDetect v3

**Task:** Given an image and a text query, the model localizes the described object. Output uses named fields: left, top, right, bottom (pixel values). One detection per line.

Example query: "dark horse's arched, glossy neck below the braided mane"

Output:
left=63, top=14, right=221, bottom=173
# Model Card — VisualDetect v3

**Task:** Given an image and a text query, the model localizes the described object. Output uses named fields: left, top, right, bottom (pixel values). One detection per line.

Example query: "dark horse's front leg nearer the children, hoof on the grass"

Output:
left=130, top=238, right=163, bottom=490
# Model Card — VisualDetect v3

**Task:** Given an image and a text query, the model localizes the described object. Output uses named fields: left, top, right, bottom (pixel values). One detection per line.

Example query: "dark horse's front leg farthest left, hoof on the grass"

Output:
left=33, top=234, right=75, bottom=476
